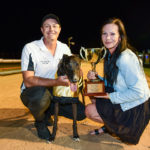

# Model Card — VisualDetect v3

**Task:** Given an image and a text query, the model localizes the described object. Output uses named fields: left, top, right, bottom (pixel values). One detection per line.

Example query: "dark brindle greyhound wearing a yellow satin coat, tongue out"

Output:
left=50, top=55, right=85, bottom=141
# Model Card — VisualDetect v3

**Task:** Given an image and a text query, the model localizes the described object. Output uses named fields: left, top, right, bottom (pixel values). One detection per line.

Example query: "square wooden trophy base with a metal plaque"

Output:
left=83, top=80, right=106, bottom=96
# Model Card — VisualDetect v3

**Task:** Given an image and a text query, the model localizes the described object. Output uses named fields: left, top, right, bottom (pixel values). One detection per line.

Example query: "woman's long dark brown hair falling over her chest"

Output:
left=101, top=18, right=130, bottom=85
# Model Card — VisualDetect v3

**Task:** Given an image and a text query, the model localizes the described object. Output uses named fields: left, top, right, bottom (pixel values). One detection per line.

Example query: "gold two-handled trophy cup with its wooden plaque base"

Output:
left=80, top=47, right=106, bottom=96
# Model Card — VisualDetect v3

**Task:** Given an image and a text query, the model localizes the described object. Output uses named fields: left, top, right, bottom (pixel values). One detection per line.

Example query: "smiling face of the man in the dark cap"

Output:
left=41, top=19, right=61, bottom=40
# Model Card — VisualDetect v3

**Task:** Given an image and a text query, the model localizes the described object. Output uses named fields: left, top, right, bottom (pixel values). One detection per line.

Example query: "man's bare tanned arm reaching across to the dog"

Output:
left=22, top=71, right=70, bottom=88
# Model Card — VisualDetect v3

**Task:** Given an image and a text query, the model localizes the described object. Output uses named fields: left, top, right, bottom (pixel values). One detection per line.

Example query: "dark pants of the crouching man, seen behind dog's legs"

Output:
left=20, top=87, right=85, bottom=121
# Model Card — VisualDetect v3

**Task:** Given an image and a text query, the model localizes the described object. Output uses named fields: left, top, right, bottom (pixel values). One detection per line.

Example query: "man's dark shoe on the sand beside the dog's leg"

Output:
left=34, top=121, right=51, bottom=140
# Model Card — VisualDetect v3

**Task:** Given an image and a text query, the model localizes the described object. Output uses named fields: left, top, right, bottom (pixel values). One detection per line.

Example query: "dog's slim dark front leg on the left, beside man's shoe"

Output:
left=50, top=102, right=59, bottom=141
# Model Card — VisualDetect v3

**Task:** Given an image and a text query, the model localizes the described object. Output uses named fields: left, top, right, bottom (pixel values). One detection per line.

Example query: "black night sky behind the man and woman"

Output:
left=0, top=0, right=150, bottom=58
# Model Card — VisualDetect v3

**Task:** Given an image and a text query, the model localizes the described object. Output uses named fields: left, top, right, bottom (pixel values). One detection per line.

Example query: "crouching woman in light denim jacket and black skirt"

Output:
left=85, top=18, right=150, bottom=144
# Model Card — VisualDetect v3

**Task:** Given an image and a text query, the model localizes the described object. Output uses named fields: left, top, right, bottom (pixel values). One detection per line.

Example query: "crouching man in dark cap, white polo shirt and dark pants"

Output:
left=20, top=14, right=85, bottom=140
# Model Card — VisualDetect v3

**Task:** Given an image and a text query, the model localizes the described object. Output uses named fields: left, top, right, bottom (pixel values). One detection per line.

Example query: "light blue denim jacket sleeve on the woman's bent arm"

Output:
left=109, top=54, right=144, bottom=104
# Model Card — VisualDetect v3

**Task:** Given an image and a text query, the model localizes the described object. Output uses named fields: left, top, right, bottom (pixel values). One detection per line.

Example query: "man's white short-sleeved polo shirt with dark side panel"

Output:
left=21, top=38, right=71, bottom=90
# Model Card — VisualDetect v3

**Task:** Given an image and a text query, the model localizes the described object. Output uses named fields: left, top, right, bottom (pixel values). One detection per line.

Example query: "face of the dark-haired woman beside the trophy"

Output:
left=101, top=24, right=121, bottom=54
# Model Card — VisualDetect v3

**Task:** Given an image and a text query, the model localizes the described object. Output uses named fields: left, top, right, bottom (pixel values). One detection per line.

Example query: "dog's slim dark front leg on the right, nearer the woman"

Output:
left=72, top=103, right=80, bottom=141
